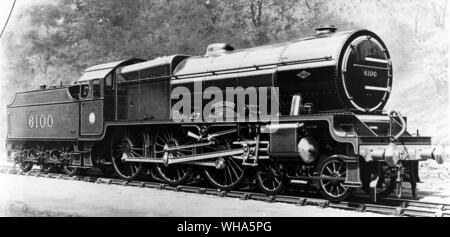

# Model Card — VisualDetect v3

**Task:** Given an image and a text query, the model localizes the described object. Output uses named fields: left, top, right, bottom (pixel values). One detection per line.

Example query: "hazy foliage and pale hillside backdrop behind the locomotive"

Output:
left=0, top=0, right=450, bottom=144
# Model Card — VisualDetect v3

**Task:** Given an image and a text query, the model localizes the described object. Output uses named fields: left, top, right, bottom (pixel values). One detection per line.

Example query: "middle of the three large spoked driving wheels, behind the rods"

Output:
left=153, top=131, right=194, bottom=186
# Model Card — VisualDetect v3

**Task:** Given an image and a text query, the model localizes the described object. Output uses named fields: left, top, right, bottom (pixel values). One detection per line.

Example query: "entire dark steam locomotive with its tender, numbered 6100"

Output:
left=7, top=26, right=442, bottom=201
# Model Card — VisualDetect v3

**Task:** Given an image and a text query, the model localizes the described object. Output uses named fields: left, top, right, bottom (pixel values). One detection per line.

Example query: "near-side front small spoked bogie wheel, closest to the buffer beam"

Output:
left=318, top=156, right=353, bottom=202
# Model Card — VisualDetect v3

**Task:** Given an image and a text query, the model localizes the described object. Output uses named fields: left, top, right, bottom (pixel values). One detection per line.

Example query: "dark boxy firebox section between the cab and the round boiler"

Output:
left=117, top=55, right=188, bottom=121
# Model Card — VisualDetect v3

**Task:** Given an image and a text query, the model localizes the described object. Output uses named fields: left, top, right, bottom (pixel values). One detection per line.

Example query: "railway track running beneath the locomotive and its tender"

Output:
left=0, top=167, right=450, bottom=217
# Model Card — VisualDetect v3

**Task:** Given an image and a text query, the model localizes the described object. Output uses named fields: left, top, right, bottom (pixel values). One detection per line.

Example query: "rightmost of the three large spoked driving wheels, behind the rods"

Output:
left=203, top=141, right=246, bottom=191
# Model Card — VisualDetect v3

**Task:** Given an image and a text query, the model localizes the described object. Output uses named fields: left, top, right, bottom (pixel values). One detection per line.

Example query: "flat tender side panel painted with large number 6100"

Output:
left=8, top=103, right=79, bottom=139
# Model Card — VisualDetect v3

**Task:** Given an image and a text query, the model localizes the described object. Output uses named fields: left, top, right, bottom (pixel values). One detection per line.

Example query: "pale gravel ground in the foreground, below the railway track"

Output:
left=0, top=174, right=381, bottom=217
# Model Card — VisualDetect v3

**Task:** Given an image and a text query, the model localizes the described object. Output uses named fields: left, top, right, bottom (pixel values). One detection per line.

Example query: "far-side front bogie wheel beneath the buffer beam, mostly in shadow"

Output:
left=361, top=164, right=396, bottom=197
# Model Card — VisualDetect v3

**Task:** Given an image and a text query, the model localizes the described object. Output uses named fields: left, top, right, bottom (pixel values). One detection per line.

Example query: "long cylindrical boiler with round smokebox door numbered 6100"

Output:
left=171, top=30, right=392, bottom=113
